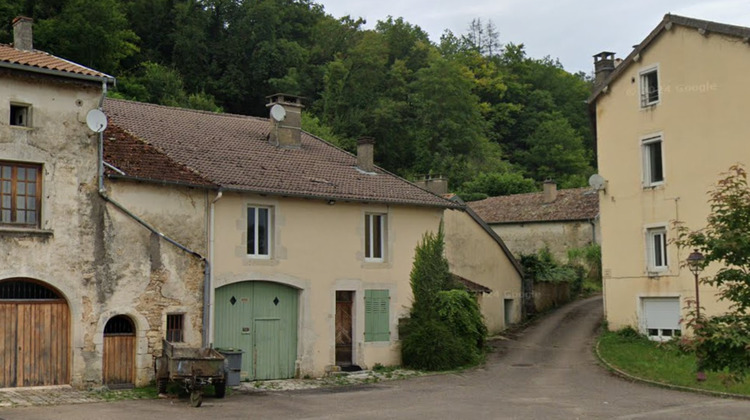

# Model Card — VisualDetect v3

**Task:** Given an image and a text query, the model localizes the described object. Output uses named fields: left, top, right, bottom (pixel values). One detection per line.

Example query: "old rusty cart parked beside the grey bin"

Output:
left=154, top=340, right=227, bottom=407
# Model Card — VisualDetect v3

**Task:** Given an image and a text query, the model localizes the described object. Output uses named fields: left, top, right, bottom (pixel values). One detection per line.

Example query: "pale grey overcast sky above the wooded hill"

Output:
left=316, top=0, right=750, bottom=73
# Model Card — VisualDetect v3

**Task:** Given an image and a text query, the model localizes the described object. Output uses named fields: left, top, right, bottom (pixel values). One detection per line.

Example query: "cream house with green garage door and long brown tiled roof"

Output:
left=104, top=95, right=521, bottom=379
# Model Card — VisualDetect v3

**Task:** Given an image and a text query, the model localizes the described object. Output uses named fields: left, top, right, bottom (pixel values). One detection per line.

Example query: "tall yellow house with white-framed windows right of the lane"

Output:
left=590, top=14, right=750, bottom=340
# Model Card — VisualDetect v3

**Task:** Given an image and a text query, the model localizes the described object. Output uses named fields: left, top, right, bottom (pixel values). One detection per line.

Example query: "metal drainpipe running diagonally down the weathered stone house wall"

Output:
left=98, top=80, right=211, bottom=347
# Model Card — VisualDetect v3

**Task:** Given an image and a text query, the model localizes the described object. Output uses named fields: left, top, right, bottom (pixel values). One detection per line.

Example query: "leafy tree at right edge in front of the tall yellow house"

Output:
left=675, top=164, right=750, bottom=380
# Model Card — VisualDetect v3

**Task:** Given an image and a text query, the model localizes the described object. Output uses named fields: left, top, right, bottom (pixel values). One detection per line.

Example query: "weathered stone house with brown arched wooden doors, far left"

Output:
left=0, top=18, right=205, bottom=387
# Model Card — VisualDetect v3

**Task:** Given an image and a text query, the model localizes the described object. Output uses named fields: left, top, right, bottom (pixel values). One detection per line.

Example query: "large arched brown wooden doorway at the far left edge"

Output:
left=0, top=278, right=70, bottom=388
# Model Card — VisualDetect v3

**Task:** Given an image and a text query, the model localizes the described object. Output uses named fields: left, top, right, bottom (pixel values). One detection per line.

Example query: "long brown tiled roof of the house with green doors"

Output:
left=104, top=99, right=462, bottom=208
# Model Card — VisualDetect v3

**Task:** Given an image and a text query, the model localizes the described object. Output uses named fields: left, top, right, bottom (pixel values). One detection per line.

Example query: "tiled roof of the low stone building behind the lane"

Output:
left=468, top=188, right=599, bottom=224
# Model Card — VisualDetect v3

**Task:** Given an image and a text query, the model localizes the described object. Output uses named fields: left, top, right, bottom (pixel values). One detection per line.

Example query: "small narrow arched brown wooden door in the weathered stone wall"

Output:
left=102, top=315, right=135, bottom=388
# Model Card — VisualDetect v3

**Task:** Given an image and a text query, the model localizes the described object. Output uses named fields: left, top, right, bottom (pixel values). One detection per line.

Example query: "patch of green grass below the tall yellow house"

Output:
left=599, top=330, right=750, bottom=395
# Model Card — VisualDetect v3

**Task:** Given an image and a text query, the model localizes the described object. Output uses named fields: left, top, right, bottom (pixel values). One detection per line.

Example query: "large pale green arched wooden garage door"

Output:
left=214, top=281, right=299, bottom=380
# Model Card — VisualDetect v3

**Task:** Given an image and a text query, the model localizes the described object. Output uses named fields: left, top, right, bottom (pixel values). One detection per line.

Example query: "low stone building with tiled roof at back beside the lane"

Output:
left=468, top=181, right=601, bottom=262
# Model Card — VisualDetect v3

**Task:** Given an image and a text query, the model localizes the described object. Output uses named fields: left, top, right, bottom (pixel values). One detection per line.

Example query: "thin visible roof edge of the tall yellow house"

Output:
left=588, top=13, right=750, bottom=103
